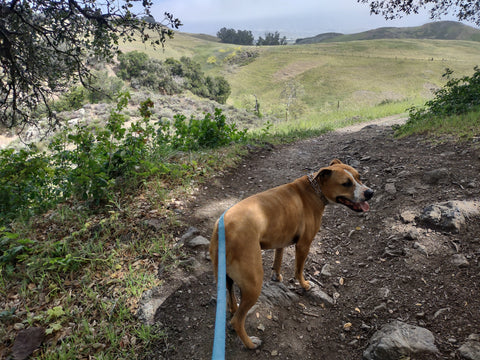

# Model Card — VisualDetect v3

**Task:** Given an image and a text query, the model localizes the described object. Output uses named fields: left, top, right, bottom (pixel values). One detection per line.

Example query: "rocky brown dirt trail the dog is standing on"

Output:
left=153, top=117, right=480, bottom=360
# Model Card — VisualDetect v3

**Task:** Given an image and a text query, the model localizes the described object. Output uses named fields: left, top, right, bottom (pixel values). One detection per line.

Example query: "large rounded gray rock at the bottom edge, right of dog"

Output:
left=363, top=320, right=438, bottom=360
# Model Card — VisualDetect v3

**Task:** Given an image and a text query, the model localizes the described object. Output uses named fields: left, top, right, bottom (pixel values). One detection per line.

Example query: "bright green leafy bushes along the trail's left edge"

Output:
left=0, top=94, right=246, bottom=225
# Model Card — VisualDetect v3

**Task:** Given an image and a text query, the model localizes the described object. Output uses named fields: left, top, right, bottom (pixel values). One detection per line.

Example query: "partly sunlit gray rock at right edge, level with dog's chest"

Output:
left=415, top=201, right=480, bottom=233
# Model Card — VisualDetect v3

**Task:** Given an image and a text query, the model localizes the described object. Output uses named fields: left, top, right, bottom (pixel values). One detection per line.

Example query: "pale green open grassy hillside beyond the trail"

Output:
left=121, top=29, right=480, bottom=133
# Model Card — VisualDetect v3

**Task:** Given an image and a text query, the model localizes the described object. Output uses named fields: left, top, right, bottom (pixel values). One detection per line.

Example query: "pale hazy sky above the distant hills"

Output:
left=152, top=0, right=472, bottom=39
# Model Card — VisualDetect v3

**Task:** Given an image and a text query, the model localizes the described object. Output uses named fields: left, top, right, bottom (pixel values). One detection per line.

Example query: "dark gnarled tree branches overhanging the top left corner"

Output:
left=0, top=0, right=182, bottom=127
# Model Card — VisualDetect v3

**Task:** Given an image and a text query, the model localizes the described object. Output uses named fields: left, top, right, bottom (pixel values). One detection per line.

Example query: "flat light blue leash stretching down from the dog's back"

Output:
left=212, top=211, right=227, bottom=360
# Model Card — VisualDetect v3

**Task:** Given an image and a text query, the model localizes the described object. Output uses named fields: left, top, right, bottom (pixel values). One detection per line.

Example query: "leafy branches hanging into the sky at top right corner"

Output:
left=357, top=0, right=480, bottom=26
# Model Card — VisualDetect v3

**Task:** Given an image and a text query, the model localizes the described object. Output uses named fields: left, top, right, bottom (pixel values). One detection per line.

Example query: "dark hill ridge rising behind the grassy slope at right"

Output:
left=295, top=21, right=480, bottom=45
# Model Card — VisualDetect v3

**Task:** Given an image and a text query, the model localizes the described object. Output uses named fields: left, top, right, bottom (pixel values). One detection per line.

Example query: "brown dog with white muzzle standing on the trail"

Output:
left=210, top=159, right=373, bottom=349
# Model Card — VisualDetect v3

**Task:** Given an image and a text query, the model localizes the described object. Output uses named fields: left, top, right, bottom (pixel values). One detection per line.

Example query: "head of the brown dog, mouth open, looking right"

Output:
left=315, top=159, right=373, bottom=212
